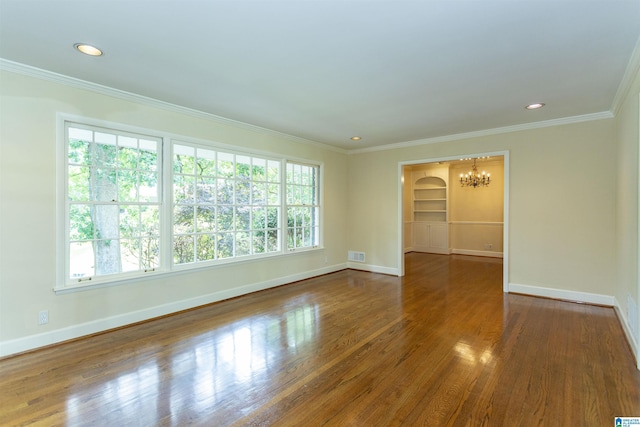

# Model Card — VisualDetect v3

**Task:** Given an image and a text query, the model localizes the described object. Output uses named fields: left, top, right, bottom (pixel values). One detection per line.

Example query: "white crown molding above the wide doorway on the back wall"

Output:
left=347, top=111, right=614, bottom=154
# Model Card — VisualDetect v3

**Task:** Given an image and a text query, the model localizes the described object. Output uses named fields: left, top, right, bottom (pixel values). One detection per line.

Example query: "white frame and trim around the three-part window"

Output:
left=53, top=113, right=324, bottom=294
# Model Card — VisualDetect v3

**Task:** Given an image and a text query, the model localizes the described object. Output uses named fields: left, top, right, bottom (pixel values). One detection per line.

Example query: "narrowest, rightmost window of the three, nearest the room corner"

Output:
left=287, top=163, right=320, bottom=250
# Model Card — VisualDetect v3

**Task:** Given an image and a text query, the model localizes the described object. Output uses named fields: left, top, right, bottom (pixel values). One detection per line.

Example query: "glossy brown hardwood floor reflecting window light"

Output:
left=0, top=253, right=640, bottom=427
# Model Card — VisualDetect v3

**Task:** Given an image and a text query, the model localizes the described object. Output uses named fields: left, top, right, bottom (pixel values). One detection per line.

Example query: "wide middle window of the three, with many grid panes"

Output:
left=173, top=144, right=281, bottom=264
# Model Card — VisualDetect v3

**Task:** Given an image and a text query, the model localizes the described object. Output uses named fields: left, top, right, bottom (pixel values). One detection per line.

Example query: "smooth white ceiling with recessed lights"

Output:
left=0, top=0, right=640, bottom=150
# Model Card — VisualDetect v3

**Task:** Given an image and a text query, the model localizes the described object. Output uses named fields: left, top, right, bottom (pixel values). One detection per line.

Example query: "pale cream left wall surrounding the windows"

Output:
left=0, top=71, right=348, bottom=356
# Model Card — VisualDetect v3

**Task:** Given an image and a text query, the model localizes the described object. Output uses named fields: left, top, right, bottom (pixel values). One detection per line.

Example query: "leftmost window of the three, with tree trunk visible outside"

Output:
left=65, top=124, right=161, bottom=281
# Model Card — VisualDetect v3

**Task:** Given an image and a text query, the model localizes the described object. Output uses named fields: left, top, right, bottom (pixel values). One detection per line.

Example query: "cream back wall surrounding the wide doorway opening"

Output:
left=349, top=118, right=616, bottom=296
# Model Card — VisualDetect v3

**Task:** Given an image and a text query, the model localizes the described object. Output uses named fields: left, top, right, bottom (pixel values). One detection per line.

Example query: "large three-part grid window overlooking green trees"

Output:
left=57, top=118, right=320, bottom=288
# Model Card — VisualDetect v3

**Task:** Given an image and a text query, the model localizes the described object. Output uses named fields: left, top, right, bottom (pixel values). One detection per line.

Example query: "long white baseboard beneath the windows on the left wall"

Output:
left=0, top=264, right=347, bottom=357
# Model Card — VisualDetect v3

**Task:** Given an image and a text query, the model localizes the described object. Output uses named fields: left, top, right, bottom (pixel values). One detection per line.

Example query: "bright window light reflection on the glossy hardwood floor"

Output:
left=66, top=304, right=319, bottom=425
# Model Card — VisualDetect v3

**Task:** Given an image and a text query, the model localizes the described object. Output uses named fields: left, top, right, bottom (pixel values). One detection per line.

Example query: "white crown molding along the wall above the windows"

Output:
left=0, top=58, right=347, bottom=154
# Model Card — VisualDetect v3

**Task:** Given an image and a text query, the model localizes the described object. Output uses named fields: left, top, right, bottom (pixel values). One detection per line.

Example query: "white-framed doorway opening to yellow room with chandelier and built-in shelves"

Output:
left=398, top=151, right=509, bottom=292
